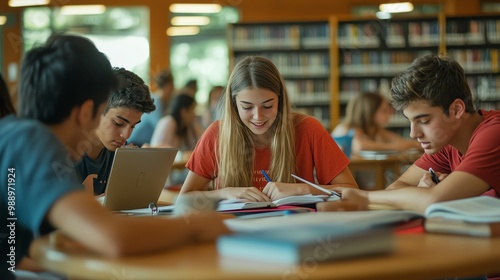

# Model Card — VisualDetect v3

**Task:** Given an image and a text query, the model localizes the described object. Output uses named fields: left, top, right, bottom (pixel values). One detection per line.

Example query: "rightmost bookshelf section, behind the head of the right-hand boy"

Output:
left=445, top=14, right=500, bottom=110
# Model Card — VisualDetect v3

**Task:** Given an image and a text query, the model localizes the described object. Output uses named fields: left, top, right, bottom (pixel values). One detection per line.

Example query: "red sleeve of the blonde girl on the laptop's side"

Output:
left=186, top=121, right=219, bottom=180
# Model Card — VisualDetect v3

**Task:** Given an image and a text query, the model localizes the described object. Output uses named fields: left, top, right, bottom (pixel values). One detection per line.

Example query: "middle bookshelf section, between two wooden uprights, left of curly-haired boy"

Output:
left=330, top=16, right=443, bottom=136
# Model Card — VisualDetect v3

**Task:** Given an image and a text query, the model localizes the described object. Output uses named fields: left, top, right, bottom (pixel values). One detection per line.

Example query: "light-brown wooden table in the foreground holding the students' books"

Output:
left=31, top=229, right=500, bottom=280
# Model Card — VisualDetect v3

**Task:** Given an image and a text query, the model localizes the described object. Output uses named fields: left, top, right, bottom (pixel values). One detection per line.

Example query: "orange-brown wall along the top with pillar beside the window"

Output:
left=0, top=0, right=481, bottom=90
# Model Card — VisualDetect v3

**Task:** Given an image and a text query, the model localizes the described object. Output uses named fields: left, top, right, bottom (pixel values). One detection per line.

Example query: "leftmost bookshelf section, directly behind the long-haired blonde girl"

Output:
left=228, top=21, right=331, bottom=129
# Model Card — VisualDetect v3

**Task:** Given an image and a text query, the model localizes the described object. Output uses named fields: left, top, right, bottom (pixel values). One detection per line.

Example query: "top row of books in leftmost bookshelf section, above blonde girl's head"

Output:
left=233, top=23, right=330, bottom=49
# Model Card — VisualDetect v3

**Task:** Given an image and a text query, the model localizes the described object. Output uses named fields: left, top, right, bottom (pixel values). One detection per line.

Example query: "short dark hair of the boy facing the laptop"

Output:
left=104, top=68, right=156, bottom=114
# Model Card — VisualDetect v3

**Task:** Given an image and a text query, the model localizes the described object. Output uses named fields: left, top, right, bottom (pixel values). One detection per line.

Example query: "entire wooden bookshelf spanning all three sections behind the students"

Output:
left=228, top=14, right=500, bottom=136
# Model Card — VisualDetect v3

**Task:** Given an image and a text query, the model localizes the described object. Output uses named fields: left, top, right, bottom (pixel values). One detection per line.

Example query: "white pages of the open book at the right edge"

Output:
left=425, top=196, right=500, bottom=223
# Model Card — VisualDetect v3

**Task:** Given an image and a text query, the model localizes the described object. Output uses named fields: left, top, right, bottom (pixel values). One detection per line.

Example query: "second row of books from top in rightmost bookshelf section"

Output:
left=448, top=48, right=500, bottom=73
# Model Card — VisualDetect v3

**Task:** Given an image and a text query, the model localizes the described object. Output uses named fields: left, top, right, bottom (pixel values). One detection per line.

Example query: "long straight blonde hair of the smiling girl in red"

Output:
left=216, top=56, right=295, bottom=187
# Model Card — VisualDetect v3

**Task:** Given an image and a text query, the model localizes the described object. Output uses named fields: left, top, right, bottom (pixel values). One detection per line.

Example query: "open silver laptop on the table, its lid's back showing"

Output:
left=102, top=148, right=178, bottom=211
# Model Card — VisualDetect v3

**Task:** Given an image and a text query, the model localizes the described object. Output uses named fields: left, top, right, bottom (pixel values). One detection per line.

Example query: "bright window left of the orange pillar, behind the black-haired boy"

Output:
left=23, top=6, right=149, bottom=84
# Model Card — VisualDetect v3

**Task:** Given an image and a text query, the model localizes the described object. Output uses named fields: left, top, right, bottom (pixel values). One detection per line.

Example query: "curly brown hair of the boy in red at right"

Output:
left=391, top=55, right=475, bottom=114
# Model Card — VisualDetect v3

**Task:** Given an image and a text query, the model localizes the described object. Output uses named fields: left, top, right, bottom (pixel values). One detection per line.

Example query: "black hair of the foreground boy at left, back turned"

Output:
left=19, top=34, right=117, bottom=124
